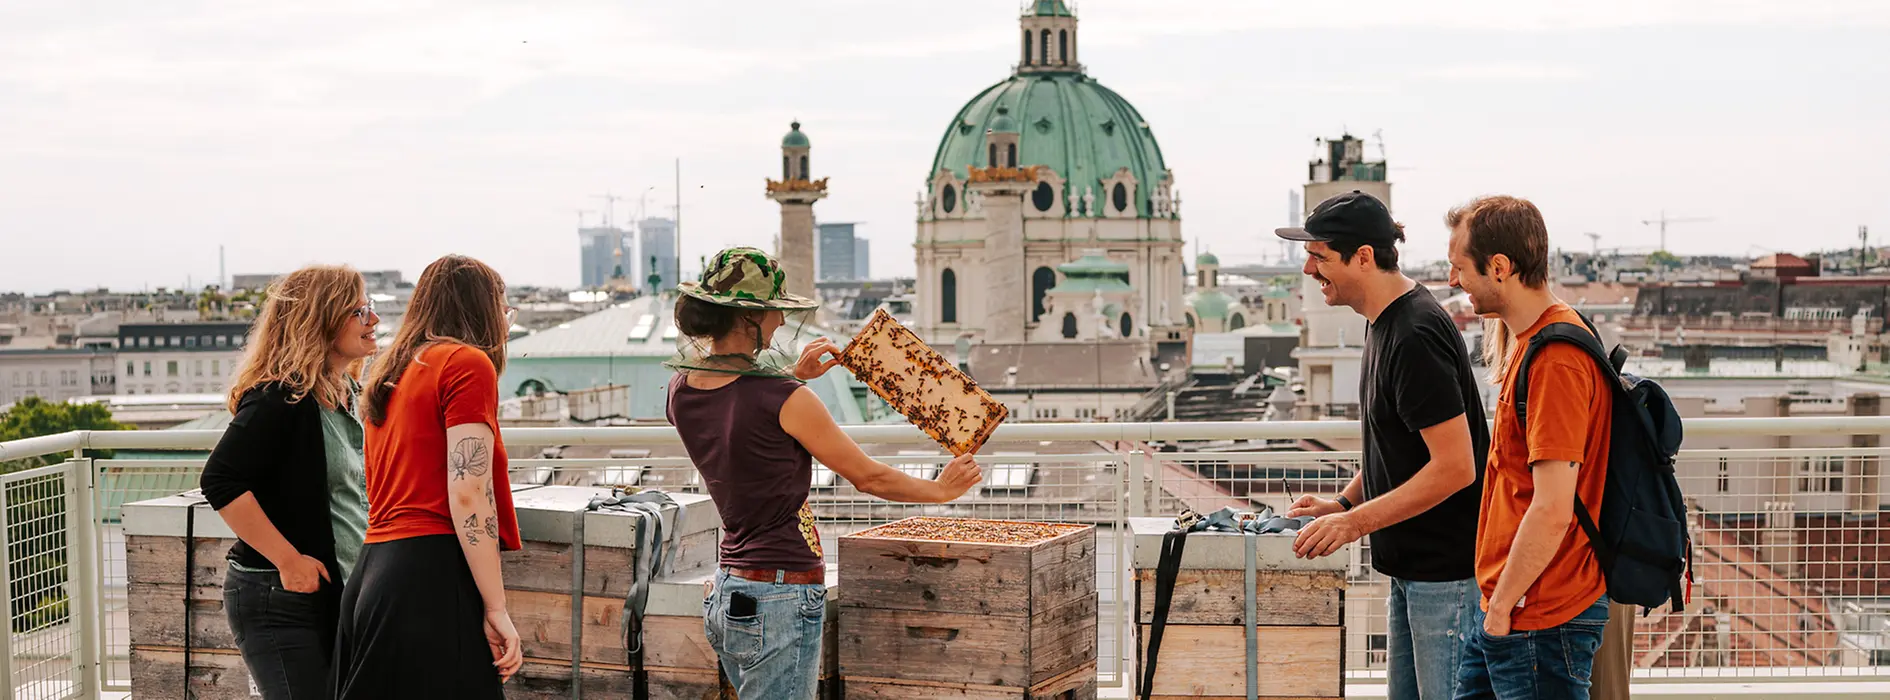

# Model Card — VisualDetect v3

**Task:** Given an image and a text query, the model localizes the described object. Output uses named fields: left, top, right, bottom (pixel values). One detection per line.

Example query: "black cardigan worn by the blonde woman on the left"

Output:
left=197, top=384, right=344, bottom=600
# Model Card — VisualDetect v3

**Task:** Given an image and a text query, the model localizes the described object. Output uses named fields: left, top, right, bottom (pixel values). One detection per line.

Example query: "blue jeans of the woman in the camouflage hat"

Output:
left=703, top=571, right=826, bottom=700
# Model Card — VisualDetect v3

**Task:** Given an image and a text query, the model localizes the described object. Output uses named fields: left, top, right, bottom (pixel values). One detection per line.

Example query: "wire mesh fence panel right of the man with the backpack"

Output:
left=1635, top=448, right=1890, bottom=677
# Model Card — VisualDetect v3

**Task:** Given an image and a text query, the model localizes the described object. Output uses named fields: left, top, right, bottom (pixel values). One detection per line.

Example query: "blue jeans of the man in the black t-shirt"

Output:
left=1385, top=577, right=1482, bottom=700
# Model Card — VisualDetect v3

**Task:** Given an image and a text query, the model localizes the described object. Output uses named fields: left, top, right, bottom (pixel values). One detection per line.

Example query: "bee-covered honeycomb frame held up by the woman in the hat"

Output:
left=839, top=308, right=1011, bottom=454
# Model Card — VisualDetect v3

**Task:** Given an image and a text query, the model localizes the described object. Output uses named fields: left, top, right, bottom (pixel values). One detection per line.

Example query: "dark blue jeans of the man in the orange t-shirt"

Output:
left=1457, top=596, right=1608, bottom=700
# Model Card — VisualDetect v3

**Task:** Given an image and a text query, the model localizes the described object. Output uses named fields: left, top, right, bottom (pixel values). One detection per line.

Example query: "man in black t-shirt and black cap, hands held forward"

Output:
left=1278, top=191, right=1489, bottom=700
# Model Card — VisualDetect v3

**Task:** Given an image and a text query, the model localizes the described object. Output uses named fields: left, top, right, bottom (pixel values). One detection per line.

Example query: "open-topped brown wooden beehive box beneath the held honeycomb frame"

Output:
left=839, top=516, right=1096, bottom=700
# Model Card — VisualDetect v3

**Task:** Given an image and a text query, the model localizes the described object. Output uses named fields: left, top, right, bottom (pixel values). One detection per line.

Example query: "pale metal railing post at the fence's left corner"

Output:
left=66, top=460, right=102, bottom=698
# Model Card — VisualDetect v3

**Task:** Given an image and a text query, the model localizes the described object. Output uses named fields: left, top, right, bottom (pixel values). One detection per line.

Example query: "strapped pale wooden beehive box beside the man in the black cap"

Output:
left=1128, top=518, right=1357, bottom=700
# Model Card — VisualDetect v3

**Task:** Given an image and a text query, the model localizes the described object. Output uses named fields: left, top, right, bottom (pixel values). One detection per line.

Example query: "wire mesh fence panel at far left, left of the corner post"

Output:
left=0, top=465, right=87, bottom=700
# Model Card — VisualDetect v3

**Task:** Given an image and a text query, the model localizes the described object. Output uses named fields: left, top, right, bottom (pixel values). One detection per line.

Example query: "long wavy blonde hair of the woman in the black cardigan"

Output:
left=229, top=265, right=367, bottom=412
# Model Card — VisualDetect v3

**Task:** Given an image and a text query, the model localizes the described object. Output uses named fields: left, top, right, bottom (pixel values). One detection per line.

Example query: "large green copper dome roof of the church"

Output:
left=926, top=73, right=1168, bottom=218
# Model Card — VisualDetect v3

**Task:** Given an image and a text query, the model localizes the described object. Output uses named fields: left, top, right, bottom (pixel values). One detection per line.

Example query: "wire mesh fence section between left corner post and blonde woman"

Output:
left=93, top=456, right=204, bottom=691
